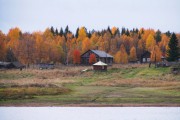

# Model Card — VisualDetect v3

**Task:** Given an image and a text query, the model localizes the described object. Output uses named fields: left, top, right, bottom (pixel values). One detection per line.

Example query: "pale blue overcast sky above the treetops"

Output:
left=0, top=0, right=180, bottom=34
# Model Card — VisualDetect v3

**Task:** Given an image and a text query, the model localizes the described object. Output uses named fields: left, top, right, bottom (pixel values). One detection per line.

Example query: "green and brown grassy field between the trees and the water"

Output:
left=0, top=64, right=180, bottom=106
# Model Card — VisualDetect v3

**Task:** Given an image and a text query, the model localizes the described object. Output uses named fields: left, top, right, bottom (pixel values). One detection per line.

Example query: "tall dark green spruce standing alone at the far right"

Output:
left=167, top=33, right=179, bottom=61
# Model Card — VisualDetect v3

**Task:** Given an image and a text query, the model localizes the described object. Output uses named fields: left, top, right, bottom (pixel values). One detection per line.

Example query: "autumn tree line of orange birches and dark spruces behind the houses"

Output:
left=0, top=26, right=180, bottom=65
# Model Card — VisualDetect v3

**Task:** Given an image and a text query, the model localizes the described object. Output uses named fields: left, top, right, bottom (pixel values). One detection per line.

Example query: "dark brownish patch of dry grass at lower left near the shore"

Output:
left=0, top=85, right=70, bottom=100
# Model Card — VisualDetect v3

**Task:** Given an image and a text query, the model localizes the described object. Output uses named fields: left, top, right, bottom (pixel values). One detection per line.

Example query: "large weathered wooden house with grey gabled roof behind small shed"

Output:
left=81, top=50, right=113, bottom=65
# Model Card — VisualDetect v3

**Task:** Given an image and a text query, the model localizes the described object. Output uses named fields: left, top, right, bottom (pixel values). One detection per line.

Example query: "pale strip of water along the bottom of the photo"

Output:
left=0, top=107, right=180, bottom=120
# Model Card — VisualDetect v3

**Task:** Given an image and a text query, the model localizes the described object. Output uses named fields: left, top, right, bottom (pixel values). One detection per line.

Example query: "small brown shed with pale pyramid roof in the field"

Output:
left=93, top=61, right=107, bottom=71
